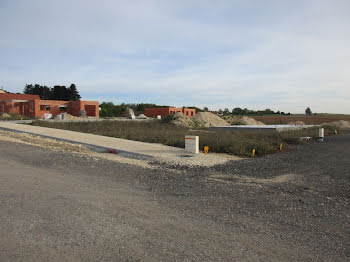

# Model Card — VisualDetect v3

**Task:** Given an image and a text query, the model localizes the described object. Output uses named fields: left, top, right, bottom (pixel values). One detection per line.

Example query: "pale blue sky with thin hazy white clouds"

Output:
left=0, top=0, right=350, bottom=114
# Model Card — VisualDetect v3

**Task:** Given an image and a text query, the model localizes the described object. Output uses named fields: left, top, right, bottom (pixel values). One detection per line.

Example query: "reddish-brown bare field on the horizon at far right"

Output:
left=251, top=115, right=350, bottom=125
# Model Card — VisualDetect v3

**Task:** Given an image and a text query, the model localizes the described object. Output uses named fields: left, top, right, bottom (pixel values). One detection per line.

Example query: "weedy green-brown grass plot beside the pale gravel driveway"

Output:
left=33, top=120, right=334, bottom=156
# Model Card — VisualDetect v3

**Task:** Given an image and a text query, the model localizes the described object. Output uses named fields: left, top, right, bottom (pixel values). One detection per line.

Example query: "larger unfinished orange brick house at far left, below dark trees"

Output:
left=0, top=93, right=99, bottom=118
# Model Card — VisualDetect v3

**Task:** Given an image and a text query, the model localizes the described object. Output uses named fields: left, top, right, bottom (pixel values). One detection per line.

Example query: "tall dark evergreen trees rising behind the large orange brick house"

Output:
left=23, top=84, right=81, bottom=101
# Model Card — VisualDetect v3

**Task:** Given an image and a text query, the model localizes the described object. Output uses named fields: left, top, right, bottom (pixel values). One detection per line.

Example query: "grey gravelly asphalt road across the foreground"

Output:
left=0, top=135, right=350, bottom=261
